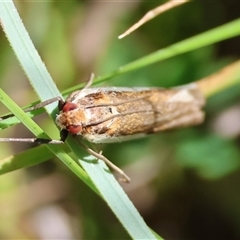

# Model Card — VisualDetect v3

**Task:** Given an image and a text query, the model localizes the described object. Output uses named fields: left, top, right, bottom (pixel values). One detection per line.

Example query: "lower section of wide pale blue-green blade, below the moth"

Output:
left=69, top=138, right=159, bottom=239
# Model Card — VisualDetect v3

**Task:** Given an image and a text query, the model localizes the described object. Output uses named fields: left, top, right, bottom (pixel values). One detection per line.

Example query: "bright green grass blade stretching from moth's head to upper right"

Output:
left=63, top=19, right=240, bottom=94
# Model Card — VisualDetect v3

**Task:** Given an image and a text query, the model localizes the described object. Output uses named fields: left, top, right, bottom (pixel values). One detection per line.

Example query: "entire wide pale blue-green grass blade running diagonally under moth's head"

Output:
left=0, top=1, right=158, bottom=239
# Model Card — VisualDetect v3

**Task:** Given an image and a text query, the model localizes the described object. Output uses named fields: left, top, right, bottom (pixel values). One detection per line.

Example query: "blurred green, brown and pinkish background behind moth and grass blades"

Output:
left=0, top=1, right=240, bottom=239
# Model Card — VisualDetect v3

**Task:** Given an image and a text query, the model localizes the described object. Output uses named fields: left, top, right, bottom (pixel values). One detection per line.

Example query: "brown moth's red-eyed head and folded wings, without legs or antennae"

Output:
left=56, top=84, right=205, bottom=143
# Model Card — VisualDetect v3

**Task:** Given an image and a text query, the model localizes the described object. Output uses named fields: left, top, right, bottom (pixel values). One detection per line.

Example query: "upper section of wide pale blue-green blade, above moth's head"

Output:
left=0, top=1, right=60, bottom=112
